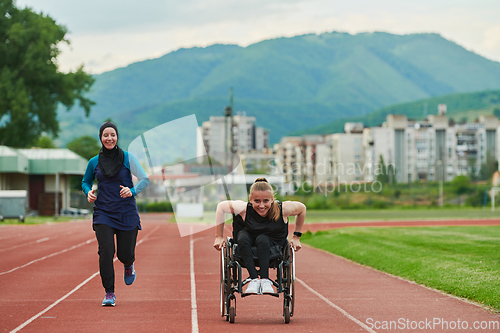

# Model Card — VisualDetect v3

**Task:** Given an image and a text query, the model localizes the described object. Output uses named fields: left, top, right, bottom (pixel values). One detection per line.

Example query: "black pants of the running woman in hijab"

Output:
left=92, top=224, right=139, bottom=293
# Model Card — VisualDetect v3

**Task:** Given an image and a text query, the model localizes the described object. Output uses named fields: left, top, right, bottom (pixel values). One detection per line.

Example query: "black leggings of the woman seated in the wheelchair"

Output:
left=238, top=230, right=272, bottom=279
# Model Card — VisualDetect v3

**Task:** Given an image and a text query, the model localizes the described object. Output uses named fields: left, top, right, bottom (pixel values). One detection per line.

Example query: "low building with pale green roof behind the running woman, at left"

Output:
left=0, top=145, right=88, bottom=215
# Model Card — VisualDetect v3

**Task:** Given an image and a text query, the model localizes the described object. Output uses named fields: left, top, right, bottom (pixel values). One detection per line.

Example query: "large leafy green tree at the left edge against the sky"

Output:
left=0, top=0, right=95, bottom=147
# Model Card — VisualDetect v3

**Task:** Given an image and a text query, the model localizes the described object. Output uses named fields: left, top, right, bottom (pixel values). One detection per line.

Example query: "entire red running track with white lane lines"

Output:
left=0, top=214, right=500, bottom=333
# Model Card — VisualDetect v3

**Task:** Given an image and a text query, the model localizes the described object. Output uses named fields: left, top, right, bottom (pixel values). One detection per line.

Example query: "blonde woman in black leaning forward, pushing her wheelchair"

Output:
left=214, top=178, right=306, bottom=294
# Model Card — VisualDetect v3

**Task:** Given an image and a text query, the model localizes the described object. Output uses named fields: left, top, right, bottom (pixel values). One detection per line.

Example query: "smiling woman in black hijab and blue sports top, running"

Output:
left=82, top=122, right=149, bottom=306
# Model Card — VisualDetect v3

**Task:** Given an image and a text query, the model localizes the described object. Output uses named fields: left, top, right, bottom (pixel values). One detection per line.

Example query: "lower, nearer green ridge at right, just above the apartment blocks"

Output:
left=291, top=90, right=500, bottom=136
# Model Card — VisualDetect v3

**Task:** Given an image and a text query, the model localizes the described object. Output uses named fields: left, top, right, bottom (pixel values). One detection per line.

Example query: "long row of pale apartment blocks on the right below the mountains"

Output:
left=275, top=113, right=500, bottom=186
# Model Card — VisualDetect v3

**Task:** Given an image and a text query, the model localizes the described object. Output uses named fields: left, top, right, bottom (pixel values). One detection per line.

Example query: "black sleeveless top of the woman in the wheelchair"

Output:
left=245, top=201, right=288, bottom=245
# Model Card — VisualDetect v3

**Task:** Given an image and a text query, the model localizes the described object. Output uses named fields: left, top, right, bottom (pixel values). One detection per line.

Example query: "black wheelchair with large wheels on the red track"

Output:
left=220, top=215, right=295, bottom=324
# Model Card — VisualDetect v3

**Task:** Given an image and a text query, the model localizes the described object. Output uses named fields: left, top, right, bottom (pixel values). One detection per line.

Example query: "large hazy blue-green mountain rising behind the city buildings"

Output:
left=59, top=32, right=500, bottom=145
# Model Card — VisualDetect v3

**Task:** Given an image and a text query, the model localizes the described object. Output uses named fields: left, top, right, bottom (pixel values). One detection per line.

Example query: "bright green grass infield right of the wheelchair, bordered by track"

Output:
left=301, top=226, right=500, bottom=311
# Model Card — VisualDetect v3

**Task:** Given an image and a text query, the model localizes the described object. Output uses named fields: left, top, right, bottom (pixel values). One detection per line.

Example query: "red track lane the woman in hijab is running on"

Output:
left=5, top=219, right=191, bottom=332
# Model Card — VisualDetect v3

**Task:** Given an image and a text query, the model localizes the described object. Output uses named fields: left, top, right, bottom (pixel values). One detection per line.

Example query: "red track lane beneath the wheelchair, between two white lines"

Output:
left=195, top=227, right=370, bottom=332
